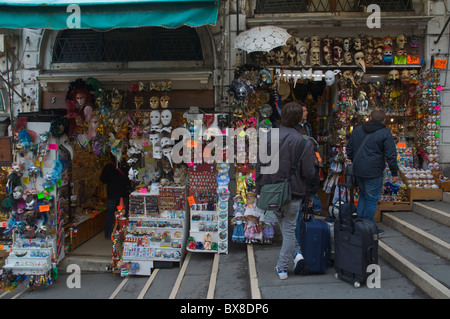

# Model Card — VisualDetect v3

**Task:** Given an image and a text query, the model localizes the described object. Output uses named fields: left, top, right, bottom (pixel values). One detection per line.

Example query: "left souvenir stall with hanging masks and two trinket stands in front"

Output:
left=40, top=78, right=236, bottom=276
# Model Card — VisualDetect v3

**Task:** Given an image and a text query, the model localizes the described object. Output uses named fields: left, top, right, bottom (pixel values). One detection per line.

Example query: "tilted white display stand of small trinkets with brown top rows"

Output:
left=122, top=187, right=187, bottom=276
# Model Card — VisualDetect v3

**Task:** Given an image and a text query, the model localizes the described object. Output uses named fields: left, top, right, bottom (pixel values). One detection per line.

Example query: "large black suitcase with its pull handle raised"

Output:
left=334, top=184, right=378, bottom=288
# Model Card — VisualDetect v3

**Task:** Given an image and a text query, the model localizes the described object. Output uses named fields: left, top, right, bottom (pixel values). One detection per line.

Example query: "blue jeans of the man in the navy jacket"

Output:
left=355, top=176, right=383, bottom=222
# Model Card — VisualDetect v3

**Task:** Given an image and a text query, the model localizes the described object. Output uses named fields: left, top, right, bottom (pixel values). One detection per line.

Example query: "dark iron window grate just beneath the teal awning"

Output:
left=52, top=27, right=203, bottom=63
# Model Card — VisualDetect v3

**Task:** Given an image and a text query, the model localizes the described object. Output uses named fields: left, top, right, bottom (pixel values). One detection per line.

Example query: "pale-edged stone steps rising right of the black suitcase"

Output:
left=379, top=193, right=450, bottom=299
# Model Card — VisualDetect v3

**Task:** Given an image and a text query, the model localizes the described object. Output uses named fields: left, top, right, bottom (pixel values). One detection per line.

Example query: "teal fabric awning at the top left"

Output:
left=0, top=0, right=219, bottom=30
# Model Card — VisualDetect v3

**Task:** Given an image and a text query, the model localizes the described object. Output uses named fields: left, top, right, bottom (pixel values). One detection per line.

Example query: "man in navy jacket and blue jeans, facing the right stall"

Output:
left=346, top=109, right=399, bottom=221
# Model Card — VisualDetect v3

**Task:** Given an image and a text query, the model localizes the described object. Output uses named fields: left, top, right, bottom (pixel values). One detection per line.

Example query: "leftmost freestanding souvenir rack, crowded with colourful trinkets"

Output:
left=1, top=114, right=71, bottom=291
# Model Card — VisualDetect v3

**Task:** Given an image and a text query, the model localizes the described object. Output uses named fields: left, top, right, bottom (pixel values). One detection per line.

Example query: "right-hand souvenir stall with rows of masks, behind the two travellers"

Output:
left=237, top=34, right=447, bottom=220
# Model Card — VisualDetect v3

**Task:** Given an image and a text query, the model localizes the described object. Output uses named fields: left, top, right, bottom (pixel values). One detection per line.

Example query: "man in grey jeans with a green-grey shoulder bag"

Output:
left=255, top=102, right=319, bottom=280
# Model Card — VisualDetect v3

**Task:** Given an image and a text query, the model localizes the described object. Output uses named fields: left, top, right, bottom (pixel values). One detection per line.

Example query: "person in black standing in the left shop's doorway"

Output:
left=100, top=153, right=131, bottom=239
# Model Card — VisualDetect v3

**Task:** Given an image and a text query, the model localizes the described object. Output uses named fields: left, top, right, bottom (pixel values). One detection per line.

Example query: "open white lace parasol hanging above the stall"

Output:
left=233, top=26, right=291, bottom=53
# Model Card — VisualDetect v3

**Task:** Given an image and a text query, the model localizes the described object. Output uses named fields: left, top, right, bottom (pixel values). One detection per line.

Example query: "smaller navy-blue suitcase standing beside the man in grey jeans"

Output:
left=300, top=207, right=331, bottom=274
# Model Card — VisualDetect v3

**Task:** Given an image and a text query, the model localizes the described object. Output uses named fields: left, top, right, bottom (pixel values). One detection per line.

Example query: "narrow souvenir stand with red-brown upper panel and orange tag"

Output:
left=186, top=163, right=230, bottom=253
